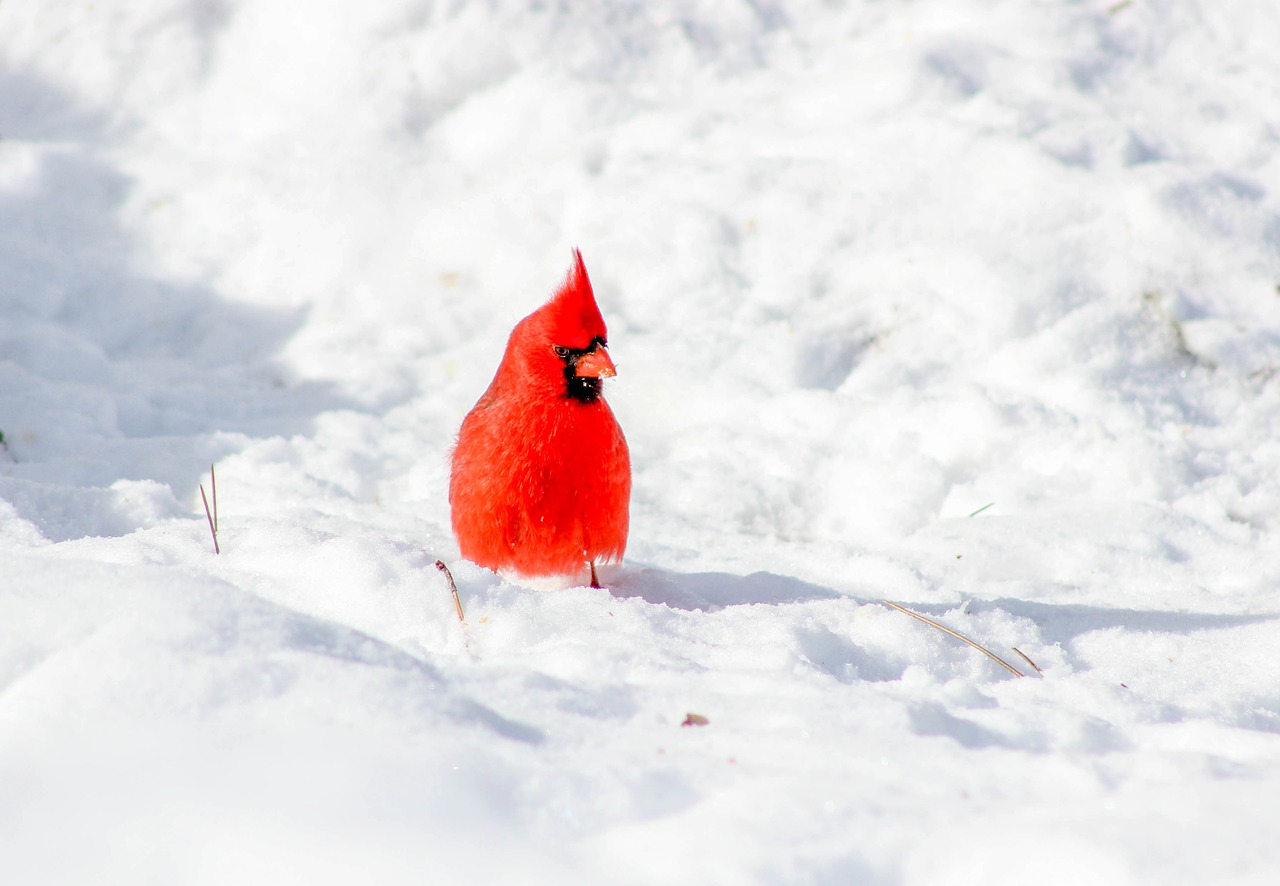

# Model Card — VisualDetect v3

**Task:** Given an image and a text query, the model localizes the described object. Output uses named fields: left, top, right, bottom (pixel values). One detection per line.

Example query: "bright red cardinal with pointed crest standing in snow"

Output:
left=449, top=250, right=631, bottom=588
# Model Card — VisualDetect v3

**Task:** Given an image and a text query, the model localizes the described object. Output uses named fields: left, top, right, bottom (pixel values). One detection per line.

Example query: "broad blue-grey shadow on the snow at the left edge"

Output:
left=0, top=60, right=356, bottom=540
